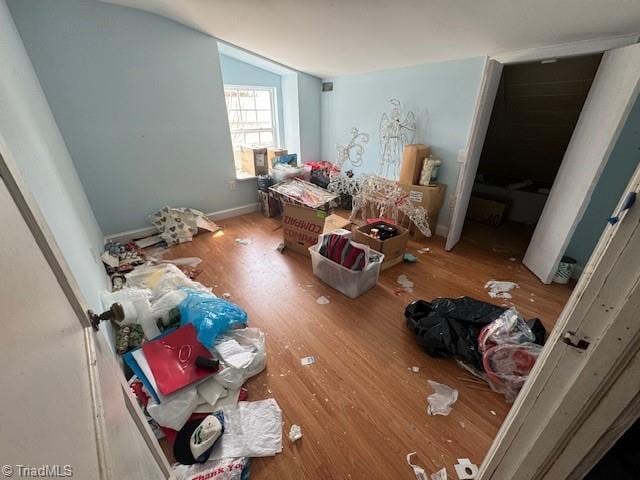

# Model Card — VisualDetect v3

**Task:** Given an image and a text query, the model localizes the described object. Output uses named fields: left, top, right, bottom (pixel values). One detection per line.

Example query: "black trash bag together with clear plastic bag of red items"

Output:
left=405, top=297, right=546, bottom=401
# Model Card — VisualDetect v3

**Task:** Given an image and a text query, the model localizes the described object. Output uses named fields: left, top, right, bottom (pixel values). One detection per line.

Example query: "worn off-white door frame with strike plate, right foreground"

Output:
left=477, top=162, right=640, bottom=480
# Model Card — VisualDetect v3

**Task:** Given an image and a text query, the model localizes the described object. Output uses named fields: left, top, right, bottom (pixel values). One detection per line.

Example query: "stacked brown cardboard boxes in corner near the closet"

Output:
left=398, top=144, right=446, bottom=240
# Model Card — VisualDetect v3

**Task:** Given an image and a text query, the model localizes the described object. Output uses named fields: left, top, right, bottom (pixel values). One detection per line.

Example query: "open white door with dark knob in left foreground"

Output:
left=0, top=173, right=169, bottom=480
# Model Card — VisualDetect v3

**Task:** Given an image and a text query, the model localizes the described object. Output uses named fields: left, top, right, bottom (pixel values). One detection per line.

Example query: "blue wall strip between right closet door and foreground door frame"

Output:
left=566, top=98, right=640, bottom=266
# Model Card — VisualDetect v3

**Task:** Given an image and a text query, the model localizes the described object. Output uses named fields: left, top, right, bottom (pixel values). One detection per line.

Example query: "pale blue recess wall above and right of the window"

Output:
left=220, top=54, right=288, bottom=148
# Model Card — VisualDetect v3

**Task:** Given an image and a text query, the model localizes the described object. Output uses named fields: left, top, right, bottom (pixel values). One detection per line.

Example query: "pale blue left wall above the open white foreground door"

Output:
left=0, top=0, right=108, bottom=312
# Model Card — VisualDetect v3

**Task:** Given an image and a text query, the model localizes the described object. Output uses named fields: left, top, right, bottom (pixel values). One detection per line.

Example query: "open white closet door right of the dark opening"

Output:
left=523, top=45, right=640, bottom=283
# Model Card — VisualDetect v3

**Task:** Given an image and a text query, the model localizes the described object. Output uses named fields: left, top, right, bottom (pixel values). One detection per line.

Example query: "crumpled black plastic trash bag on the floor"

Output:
left=404, top=297, right=506, bottom=370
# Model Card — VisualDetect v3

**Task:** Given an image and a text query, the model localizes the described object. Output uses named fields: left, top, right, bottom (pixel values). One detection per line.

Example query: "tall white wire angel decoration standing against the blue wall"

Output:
left=378, top=98, right=416, bottom=180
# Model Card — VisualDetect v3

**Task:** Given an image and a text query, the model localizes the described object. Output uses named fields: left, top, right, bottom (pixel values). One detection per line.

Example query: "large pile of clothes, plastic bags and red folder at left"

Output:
left=98, top=263, right=282, bottom=474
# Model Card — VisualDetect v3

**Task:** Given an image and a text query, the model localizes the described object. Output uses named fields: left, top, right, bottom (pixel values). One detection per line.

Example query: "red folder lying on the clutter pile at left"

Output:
left=142, top=323, right=211, bottom=395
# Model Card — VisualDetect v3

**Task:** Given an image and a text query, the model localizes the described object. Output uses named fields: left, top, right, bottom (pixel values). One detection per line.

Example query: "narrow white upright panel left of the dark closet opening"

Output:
left=445, top=59, right=502, bottom=250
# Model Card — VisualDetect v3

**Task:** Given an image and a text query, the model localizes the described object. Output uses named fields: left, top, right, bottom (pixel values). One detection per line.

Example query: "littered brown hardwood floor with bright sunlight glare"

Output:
left=165, top=213, right=571, bottom=480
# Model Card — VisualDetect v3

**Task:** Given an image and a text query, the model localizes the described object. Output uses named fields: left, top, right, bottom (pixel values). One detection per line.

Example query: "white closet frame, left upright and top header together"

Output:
left=445, top=33, right=640, bottom=251
